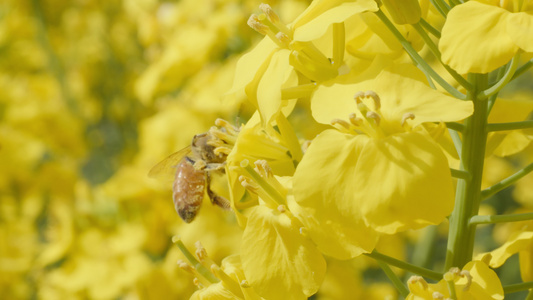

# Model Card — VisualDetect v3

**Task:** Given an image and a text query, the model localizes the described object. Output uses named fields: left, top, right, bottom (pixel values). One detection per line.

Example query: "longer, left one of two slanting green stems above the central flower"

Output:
left=375, top=10, right=466, bottom=100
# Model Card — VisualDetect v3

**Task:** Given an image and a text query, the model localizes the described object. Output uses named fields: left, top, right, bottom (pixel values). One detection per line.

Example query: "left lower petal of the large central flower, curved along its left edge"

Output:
left=290, top=130, right=377, bottom=259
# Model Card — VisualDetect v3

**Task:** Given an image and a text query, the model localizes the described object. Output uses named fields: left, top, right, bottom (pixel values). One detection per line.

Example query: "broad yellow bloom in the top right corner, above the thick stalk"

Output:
left=439, top=1, right=533, bottom=74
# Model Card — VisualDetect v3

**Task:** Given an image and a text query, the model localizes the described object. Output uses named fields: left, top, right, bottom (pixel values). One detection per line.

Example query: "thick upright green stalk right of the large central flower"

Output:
left=445, top=74, right=488, bottom=270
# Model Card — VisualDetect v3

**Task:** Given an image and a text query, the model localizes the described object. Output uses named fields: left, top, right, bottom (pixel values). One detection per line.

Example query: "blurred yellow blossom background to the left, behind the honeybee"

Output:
left=0, top=0, right=308, bottom=299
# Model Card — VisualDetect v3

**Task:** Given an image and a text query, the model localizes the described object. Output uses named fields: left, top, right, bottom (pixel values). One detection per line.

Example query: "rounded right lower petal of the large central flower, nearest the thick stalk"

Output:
left=353, top=132, right=454, bottom=234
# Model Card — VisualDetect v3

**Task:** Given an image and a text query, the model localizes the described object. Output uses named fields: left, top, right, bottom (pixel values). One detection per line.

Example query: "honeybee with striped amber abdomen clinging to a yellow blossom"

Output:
left=148, top=132, right=231, bottom=223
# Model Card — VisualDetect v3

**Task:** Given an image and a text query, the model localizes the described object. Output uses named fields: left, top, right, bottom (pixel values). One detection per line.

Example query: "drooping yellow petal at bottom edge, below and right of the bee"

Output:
left=241, top=206, right=326, bottom=299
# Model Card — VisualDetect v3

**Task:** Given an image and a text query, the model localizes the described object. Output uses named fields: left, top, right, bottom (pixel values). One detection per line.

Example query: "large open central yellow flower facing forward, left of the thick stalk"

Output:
left=294, top=65, right=473, bottom=258
